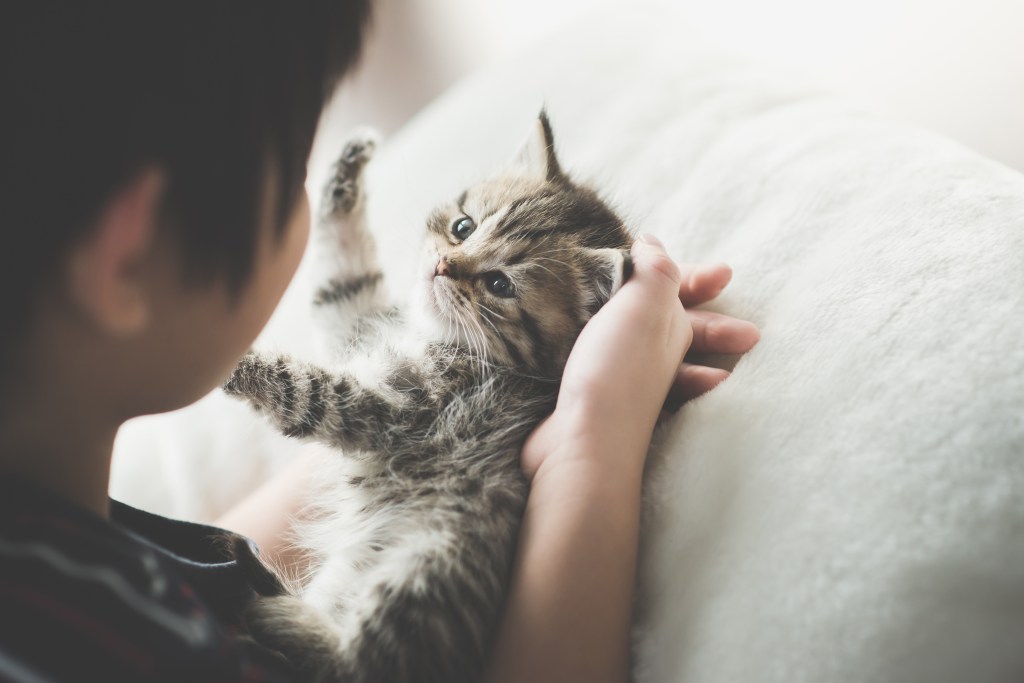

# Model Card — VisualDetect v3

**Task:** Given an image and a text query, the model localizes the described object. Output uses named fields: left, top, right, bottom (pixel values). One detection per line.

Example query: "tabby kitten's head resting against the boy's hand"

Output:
left=418, top=112, right=633, bottom=377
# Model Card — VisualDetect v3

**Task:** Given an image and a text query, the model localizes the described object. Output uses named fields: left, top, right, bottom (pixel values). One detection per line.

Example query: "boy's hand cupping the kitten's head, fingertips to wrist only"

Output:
left=521, top=237, right=760, bottom=478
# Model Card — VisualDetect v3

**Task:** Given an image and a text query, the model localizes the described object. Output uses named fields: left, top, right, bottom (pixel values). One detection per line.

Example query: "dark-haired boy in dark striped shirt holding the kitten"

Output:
left=0, top=0, right=758, bottom=681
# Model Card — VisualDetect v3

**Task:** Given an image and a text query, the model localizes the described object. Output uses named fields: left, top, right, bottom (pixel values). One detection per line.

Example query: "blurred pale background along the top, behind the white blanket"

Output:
left=313, top=0, right=1024, bottom=171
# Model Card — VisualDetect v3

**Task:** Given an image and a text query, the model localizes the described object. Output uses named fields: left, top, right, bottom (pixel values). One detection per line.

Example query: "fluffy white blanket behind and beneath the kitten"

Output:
left=114, top=3, right=1024, bottom=683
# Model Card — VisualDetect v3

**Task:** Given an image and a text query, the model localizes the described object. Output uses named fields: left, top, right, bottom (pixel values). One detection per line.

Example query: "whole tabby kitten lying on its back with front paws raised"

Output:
left=225, top=112, right=632, bottom=683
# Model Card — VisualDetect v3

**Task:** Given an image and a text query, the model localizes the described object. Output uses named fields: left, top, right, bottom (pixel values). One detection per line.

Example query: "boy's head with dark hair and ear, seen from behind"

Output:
left=0, top=0, right=369, bottom=417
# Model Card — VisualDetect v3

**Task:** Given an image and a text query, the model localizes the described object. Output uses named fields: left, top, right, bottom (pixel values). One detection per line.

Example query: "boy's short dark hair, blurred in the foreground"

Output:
left=0, top=0, right=370, bottom=368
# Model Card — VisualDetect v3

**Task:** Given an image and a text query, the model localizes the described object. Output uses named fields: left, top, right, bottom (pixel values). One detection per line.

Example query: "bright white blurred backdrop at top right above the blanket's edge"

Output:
left=680, top=0, right=1024, bottom=170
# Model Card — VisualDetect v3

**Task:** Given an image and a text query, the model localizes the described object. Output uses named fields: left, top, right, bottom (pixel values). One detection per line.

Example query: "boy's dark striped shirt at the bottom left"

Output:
left=0, top=474, right=301, bottom=683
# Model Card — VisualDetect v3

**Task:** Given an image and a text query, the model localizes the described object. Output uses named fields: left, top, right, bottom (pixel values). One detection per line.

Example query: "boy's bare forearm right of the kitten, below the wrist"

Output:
left=487, top=444, right=642, bottom=683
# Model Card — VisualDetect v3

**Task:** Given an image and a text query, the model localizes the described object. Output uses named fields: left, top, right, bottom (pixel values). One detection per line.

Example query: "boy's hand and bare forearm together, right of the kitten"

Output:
left=486, top=238, right=758, bottom=683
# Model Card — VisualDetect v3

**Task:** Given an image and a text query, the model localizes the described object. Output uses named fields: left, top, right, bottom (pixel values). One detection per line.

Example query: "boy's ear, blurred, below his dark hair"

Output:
left=68, top=167, right=164, bottom=335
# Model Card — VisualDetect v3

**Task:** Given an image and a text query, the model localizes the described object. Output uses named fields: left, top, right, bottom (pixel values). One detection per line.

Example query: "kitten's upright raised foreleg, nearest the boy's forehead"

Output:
left=313, top=132, right=391, bottom=346
